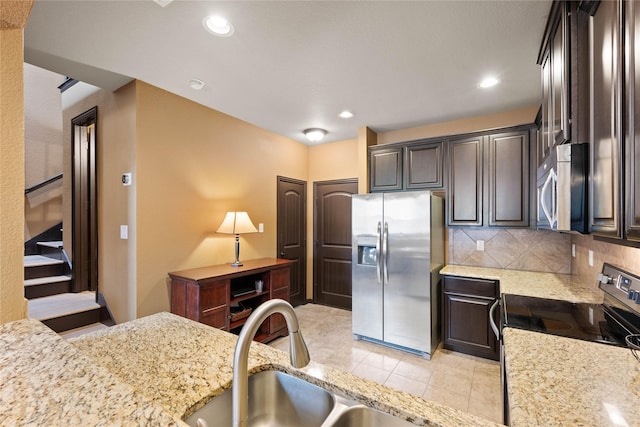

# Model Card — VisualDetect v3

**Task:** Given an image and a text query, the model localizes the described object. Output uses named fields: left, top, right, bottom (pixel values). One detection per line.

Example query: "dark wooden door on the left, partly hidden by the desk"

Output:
left=277, top=176, right=307, bottom=307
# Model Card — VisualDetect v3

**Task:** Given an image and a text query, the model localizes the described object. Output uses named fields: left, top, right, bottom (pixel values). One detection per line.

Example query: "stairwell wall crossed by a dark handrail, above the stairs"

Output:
left=24, top=63, right=64, bottom=241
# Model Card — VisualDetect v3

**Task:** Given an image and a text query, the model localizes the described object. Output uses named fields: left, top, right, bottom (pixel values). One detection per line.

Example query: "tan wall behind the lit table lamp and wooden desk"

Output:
left=134, top=82, right=309, bottom=317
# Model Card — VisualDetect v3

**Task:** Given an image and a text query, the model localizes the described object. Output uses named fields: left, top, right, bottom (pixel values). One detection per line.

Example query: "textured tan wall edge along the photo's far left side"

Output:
left=0, top=1, right=33, bottom=323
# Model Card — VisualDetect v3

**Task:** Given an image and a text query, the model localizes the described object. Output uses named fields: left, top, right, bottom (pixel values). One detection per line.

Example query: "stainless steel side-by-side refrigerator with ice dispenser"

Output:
left=352, top=191, right=444, bottom=359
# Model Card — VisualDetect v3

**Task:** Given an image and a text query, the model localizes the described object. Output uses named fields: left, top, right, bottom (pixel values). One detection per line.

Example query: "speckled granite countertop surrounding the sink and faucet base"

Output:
left=72, top=313, right=496, bottom=426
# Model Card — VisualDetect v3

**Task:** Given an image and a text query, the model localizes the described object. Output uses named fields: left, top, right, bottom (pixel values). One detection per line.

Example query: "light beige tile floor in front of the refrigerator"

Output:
left=271, top=304, right=502, bottom=424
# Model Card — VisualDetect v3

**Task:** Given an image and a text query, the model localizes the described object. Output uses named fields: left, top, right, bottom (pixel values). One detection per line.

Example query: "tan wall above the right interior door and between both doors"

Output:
left=307, top=139, right=360, bottom=299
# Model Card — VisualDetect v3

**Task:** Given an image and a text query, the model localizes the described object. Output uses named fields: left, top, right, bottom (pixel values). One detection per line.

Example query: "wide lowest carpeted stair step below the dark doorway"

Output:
left=28, top=291, right=100, bottom=321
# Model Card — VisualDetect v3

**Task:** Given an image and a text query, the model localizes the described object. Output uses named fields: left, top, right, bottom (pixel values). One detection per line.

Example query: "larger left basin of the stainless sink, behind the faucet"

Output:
left=185, top=371, right=335, bottom=427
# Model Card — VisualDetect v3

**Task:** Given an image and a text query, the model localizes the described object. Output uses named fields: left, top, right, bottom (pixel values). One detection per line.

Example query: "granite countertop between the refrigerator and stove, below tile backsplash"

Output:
left=440, top=265, right=603, bottom=304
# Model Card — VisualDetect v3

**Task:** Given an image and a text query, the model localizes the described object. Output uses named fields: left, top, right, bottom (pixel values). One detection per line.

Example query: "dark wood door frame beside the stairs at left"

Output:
left=71, top=106, right=98, bottom=292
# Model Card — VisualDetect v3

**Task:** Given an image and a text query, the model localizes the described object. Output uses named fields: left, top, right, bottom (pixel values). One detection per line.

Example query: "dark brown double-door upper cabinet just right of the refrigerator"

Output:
left=447, top=127, right=532, bottom=227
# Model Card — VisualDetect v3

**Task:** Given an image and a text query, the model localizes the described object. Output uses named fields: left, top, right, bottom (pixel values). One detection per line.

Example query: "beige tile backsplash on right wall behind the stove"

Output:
left=571, top=234, right=640, bottom=289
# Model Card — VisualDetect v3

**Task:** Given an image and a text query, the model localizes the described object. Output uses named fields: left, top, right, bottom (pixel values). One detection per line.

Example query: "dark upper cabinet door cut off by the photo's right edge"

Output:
left=624, top=2, right=640, bottom=241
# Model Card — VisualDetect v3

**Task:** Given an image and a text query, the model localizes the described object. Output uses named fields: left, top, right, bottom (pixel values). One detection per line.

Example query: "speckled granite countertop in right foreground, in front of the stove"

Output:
left=504, top=328, right=640, bottom=427
